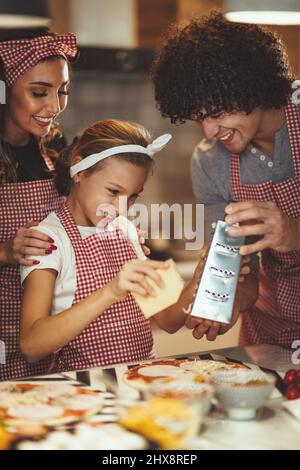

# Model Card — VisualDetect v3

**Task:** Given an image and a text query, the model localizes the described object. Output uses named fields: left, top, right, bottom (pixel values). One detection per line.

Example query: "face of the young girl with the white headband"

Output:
left=68, top=157, right=149, bottom=226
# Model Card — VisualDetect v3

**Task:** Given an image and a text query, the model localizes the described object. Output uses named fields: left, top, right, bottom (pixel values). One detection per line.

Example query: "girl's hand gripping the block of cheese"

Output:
left=109, top=260, right=168, bottom=301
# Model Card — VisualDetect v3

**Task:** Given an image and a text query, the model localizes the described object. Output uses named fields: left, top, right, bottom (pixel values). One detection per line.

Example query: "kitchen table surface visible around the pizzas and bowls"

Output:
left=3, top=345, right=300, bottom=450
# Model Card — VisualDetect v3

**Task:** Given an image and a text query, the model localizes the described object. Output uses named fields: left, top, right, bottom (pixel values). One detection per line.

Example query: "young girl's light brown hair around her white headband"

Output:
left=55, top=119, right=153, bottom=196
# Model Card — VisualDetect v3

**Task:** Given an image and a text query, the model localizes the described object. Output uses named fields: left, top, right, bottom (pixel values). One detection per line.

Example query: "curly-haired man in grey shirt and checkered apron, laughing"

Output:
left=153, top=12, right=300, bottom=347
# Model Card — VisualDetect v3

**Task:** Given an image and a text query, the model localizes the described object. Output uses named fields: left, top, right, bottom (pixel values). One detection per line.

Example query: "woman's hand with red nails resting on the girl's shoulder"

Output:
left=5, top=221, right=57, bottom=266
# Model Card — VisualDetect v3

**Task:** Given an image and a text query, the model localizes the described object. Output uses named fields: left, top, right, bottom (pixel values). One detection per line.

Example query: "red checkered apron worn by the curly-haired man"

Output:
left=231, top=101, right=300, bottom=348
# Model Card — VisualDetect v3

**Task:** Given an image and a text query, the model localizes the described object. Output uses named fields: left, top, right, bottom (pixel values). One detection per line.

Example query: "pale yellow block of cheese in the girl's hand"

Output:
left=133, top=259, right=184, bottom=318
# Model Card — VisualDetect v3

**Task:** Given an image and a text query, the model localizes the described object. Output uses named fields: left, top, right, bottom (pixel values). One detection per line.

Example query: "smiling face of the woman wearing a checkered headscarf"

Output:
left=4, top=58, right=70, bottom=145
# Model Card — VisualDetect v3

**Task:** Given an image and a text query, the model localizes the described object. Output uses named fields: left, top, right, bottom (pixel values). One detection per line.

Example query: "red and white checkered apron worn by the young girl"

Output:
left=54, top=204, right=154, bottom=371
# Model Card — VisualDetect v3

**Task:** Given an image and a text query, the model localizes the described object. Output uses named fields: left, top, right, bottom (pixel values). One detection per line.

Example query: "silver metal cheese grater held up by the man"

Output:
left=185, top=220, right=245, bottom=323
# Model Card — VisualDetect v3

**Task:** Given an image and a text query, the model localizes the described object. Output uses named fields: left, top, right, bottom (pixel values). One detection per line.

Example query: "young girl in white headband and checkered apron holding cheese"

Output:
left=20, top=120, right=247, bottom=371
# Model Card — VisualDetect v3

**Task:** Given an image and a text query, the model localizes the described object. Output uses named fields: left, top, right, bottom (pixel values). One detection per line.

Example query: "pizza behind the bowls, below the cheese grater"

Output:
left=123, top=359, right=248, bottom=391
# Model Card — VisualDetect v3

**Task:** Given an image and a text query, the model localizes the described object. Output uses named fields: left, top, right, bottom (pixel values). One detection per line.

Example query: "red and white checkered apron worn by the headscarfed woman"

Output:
left=0, top=172, right=64, bottom=380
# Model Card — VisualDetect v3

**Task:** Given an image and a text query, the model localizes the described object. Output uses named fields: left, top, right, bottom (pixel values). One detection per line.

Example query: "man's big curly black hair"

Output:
left=152, top=12, right=294, bottom=123
